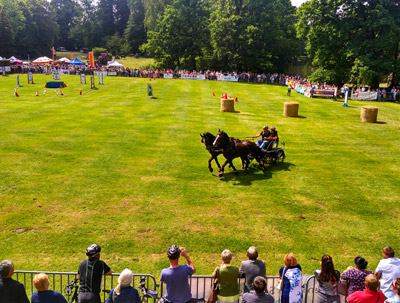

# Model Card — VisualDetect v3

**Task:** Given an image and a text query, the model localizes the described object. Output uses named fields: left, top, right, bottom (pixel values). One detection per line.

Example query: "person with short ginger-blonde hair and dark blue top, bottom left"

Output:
left=31, top=274, right=67, bottom=303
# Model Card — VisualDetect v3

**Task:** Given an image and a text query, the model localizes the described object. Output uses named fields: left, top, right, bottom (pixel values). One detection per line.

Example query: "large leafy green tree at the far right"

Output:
left=297, top=0, right=399, bottom=87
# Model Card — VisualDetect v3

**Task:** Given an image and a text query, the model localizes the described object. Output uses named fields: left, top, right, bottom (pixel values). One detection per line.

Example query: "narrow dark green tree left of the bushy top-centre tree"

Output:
left=125, top=0, right=146, bottom=53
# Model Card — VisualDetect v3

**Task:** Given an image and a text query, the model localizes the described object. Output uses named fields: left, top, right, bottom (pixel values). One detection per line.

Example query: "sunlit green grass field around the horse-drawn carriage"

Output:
left=0, top=75, right=400, bottom=277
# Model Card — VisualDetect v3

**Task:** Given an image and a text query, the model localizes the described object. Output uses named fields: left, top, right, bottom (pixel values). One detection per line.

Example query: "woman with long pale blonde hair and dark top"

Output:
left=105, top=268, right=140, bottom=303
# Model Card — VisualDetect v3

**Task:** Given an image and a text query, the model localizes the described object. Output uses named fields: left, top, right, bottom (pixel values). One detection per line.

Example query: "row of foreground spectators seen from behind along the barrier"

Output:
left=0, top=244, right=400, bottom=303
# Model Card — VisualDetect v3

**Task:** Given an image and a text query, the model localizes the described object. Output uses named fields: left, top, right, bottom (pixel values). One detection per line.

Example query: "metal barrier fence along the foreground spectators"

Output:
left=13, top=270, right=317, bottom=303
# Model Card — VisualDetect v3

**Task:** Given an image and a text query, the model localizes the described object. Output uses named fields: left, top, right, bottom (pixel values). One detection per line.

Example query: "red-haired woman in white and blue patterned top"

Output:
left=279, top=253, right=303, bottom=303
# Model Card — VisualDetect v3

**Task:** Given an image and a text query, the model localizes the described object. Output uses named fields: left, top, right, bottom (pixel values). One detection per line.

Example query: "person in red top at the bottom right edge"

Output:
left=347, top=274, right=385, bottom=303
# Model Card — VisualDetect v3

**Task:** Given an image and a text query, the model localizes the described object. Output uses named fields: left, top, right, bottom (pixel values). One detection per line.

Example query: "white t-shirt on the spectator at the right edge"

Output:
left=375, top=258, right=400, bottom=298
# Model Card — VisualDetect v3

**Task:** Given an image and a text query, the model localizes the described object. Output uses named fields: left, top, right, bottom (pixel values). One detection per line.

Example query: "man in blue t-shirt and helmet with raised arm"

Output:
left=160, top=245, right=196, bottom=303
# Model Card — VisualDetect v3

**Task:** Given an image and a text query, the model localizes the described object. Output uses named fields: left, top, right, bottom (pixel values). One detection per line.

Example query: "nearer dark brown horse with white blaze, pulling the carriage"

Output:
left=209, top=130, right=264, bottom=177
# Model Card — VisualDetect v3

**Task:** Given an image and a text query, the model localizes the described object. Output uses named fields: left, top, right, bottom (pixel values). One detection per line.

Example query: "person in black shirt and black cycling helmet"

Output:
left=78, top=244, right=111, bottom=303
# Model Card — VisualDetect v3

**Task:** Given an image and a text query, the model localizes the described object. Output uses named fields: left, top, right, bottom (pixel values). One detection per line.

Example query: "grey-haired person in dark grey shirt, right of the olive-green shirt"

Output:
left=239, top=246, right=266, bottom=292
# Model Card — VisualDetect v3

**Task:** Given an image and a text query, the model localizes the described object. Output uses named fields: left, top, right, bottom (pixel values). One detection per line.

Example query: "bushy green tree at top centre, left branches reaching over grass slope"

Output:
left=143, top=0, right=209, bottom=69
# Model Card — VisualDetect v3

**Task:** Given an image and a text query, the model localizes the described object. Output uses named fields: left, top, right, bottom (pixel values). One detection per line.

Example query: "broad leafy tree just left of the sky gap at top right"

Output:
left=210, top=0, right=298, bottom=72
